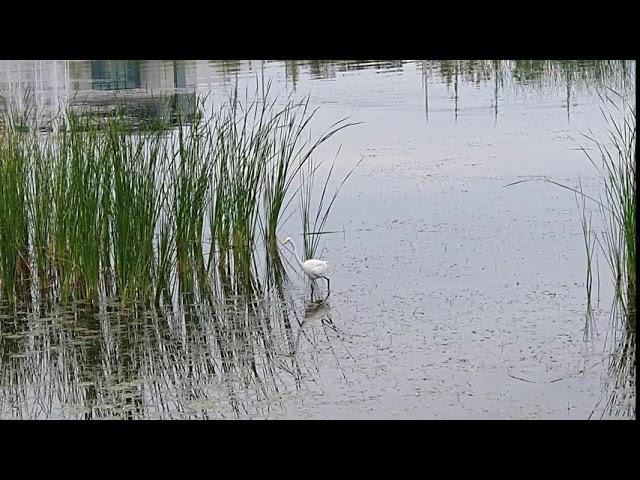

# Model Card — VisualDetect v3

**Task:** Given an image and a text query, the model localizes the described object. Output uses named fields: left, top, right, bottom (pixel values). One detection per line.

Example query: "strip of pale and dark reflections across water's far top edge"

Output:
left=0, top=60, right=635, bottom=126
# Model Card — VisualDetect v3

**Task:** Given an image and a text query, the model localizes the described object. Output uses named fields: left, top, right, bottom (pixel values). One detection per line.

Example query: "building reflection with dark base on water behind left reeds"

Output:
left=0, top=60, right=196, bottom=127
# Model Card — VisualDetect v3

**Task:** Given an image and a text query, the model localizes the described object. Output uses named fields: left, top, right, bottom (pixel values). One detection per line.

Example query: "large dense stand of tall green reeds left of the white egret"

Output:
left=0, top=87, right=358, bottom=304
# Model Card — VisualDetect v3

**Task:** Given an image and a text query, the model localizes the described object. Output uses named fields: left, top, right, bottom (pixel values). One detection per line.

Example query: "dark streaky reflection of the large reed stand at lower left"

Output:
left=0, top=284, right=339, bottom=419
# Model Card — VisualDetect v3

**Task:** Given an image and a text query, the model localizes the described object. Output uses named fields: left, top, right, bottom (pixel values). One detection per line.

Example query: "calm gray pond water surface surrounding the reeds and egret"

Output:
left=0, top=61, right=635, bottom=419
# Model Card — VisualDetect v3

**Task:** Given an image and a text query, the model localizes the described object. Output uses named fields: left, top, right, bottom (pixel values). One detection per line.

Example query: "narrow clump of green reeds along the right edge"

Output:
left=583, top=90, right=636, bottom=417
